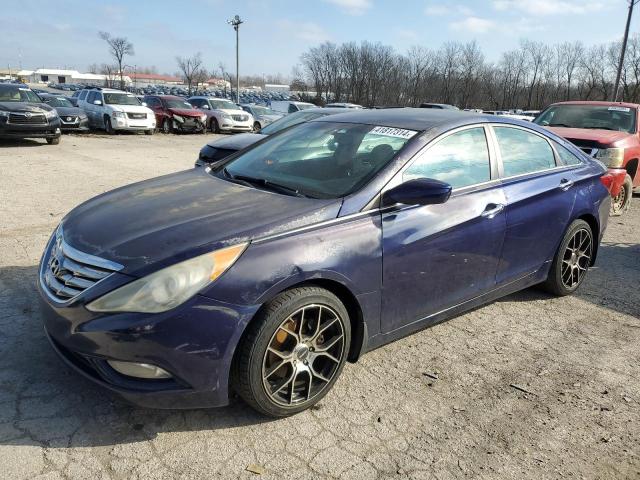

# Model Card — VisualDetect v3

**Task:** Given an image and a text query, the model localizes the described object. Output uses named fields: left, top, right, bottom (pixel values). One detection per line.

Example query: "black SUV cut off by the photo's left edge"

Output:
left=0, top=83, right=60, bottom=145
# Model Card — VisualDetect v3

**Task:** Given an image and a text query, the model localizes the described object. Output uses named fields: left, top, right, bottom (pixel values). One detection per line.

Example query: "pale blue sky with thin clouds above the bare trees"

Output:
left=0, top=0, right=640, bottom=76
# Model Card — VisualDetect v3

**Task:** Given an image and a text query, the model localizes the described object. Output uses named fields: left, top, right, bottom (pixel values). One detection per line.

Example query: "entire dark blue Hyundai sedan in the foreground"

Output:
left=38, top=109, right=611, bottom=416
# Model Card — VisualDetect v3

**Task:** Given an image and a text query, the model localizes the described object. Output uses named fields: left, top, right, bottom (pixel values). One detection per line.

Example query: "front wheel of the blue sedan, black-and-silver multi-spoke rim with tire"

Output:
left=231, top=287, right=351, bottom=417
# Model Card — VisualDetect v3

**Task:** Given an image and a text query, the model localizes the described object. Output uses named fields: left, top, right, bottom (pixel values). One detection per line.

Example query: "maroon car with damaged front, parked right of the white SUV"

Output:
left=142, top=95, right=207, bottom=133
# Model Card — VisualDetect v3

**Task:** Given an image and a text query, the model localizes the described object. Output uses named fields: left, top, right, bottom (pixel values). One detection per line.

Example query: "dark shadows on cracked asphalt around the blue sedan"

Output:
left=0, top=243, right=640, bottom=448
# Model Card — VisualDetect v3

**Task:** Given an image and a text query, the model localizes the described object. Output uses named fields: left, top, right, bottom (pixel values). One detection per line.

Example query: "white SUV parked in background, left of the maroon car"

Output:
left=78, top=87, right=156, bottom=135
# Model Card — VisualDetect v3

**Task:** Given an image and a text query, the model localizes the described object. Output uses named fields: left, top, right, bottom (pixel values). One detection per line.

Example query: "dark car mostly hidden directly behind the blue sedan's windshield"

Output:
left=196, top=108, right=345, bottom=167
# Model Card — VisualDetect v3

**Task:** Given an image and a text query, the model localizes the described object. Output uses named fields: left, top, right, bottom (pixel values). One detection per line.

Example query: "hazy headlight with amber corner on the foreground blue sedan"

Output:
left=87, top=243, right=247, bottom=313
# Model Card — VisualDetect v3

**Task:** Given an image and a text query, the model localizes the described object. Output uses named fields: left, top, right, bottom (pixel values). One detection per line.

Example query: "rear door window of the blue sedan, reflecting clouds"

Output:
left=493, top=127, right=556, bottom=177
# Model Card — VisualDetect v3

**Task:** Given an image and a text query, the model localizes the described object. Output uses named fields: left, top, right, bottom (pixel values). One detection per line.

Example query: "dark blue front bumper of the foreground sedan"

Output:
left=38, top=278, right=258, bottom=409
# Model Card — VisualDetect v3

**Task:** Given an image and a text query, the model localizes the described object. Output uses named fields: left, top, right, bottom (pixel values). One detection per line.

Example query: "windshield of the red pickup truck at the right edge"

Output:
left=534, top=105, right=637, bottom=133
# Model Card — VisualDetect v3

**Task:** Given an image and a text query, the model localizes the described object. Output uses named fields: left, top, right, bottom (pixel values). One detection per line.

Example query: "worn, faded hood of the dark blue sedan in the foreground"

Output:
left=62, top=168, right=342, bottom=276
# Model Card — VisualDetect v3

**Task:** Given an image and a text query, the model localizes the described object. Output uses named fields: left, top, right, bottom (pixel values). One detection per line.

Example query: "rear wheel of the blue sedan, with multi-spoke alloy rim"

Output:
left=542, top=220, right=595, bottom=296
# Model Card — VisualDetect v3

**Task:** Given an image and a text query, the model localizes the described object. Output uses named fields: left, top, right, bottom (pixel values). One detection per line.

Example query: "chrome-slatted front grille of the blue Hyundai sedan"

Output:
left=40, top=227, right=123, bottom=302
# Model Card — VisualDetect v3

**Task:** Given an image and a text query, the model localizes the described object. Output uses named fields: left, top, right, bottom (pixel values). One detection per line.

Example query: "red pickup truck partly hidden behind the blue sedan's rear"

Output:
left=534, top=101, right=640, bottom=215
